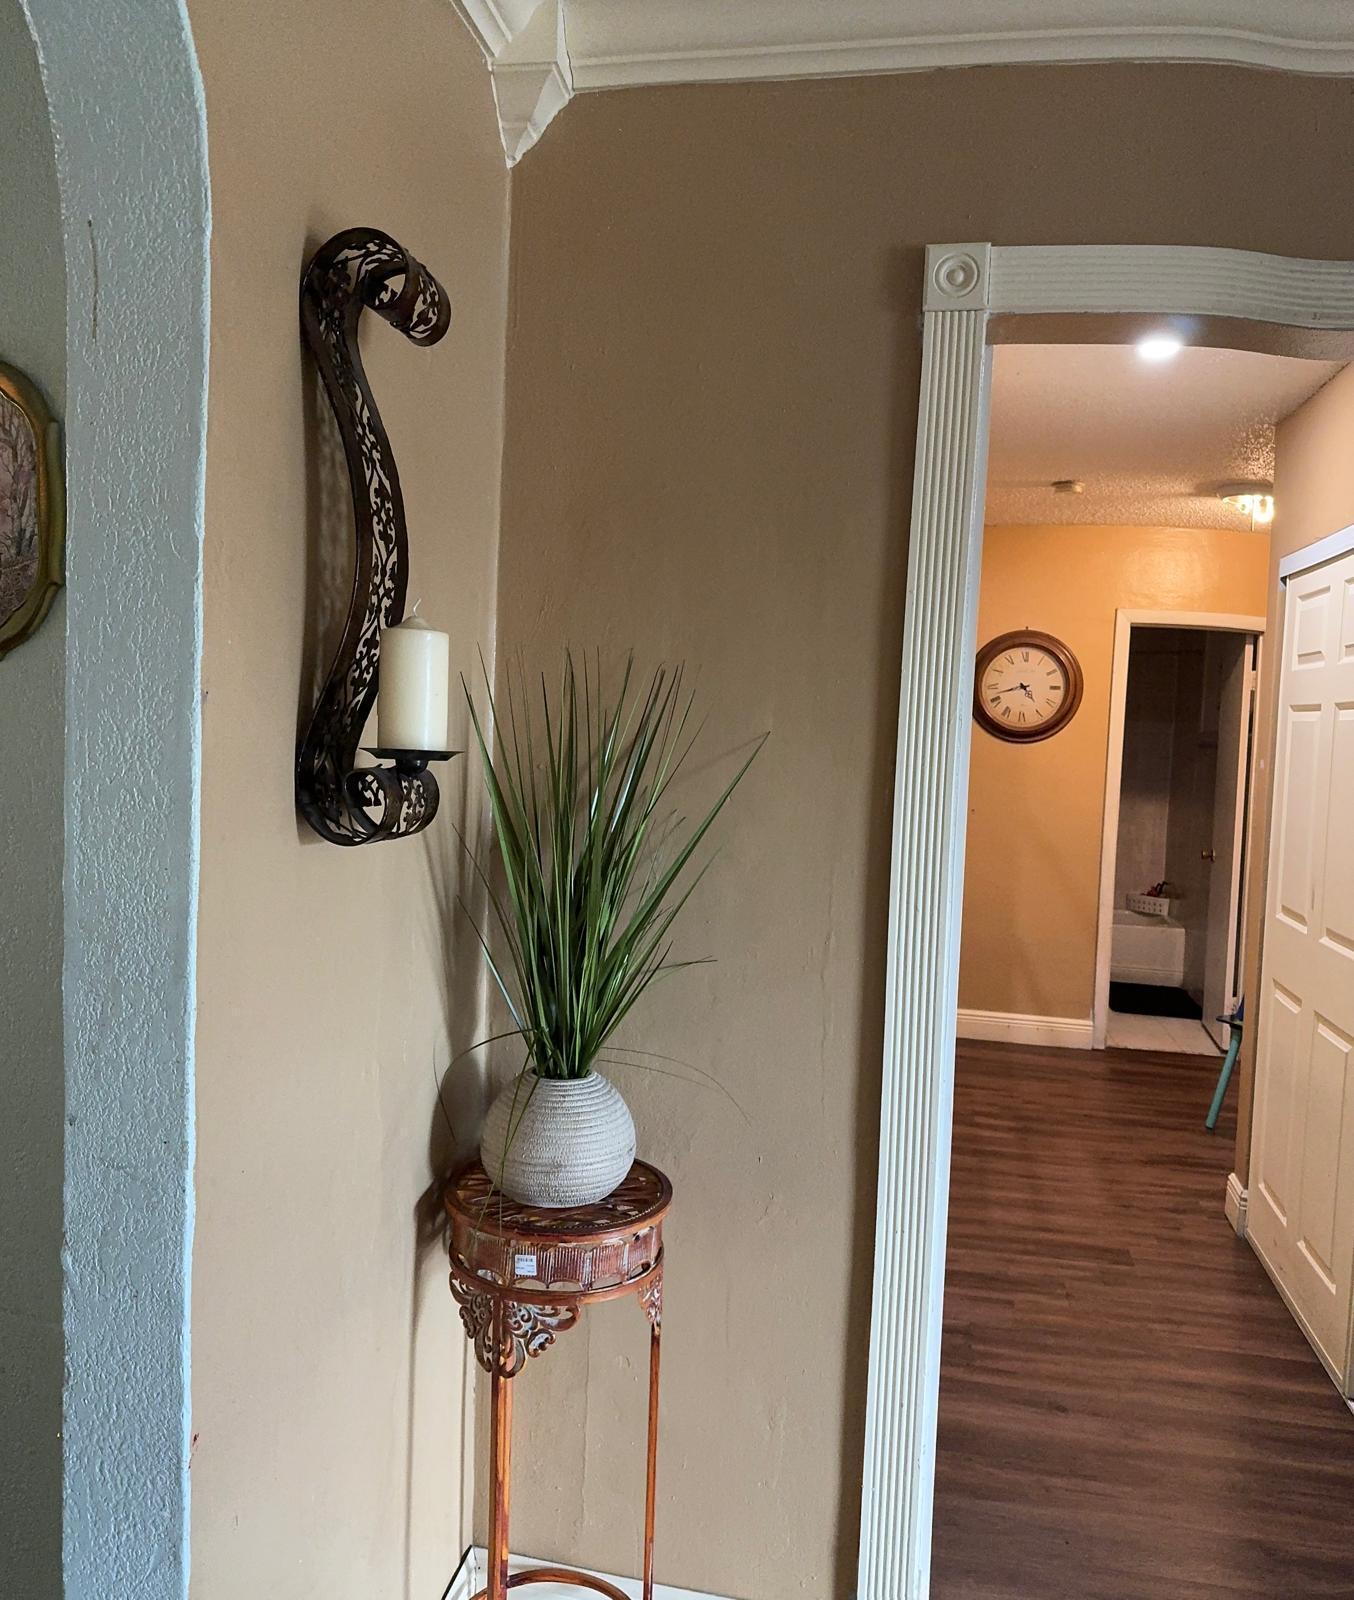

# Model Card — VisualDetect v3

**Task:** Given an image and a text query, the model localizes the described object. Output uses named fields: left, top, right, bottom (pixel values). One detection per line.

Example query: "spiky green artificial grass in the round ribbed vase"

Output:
left=466, top=654, right=765, bottom=1078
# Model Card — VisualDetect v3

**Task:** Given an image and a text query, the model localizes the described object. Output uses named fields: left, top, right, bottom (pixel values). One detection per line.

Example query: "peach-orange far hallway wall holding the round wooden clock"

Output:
left=959, top=526, right=1268, bottom=1018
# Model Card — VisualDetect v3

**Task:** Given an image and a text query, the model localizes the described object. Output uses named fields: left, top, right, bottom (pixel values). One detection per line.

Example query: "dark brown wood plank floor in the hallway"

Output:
left=931, top=1043, right=1354, bottom=1600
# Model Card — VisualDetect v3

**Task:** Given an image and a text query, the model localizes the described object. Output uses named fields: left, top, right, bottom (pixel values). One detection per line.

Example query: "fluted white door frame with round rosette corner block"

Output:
left=856, top=243, right=1354, bottom=1600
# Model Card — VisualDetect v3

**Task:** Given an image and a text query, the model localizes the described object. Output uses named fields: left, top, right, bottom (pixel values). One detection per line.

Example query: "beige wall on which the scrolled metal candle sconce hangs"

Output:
left=190, top=0, right=507, bottom=1600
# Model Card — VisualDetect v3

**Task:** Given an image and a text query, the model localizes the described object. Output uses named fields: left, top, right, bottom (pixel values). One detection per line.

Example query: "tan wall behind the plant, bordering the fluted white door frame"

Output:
left=499, top=66, right=1354, bottom=1600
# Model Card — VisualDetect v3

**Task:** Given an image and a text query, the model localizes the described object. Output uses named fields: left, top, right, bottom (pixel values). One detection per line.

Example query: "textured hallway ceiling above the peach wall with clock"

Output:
left=987, top=344, right=1341, bottom=528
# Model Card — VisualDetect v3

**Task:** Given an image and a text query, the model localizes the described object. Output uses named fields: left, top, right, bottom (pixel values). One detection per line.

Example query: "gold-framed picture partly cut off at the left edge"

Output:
left=0, top=363, right=66, bottom=656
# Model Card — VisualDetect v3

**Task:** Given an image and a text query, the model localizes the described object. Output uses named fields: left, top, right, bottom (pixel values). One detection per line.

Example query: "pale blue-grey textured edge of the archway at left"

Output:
left=18, top=0, right=208, bottom=1600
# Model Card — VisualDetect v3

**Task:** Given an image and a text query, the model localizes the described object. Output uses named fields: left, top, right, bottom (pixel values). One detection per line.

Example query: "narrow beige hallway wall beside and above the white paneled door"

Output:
left=1236, top=365, right=1354, bottom=1179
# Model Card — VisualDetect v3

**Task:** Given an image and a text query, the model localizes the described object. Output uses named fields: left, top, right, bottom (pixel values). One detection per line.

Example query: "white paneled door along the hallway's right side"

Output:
left=1247, top=540, right=1354, bottom=1395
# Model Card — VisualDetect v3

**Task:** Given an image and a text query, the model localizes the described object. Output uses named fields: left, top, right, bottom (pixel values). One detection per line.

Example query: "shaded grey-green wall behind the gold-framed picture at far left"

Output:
left=0, top=0, right=66, bottom=1600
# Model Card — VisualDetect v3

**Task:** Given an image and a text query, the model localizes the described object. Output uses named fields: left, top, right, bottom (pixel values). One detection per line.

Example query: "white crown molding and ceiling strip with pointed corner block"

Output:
left=453, top=0, right=1354, bottom=166
